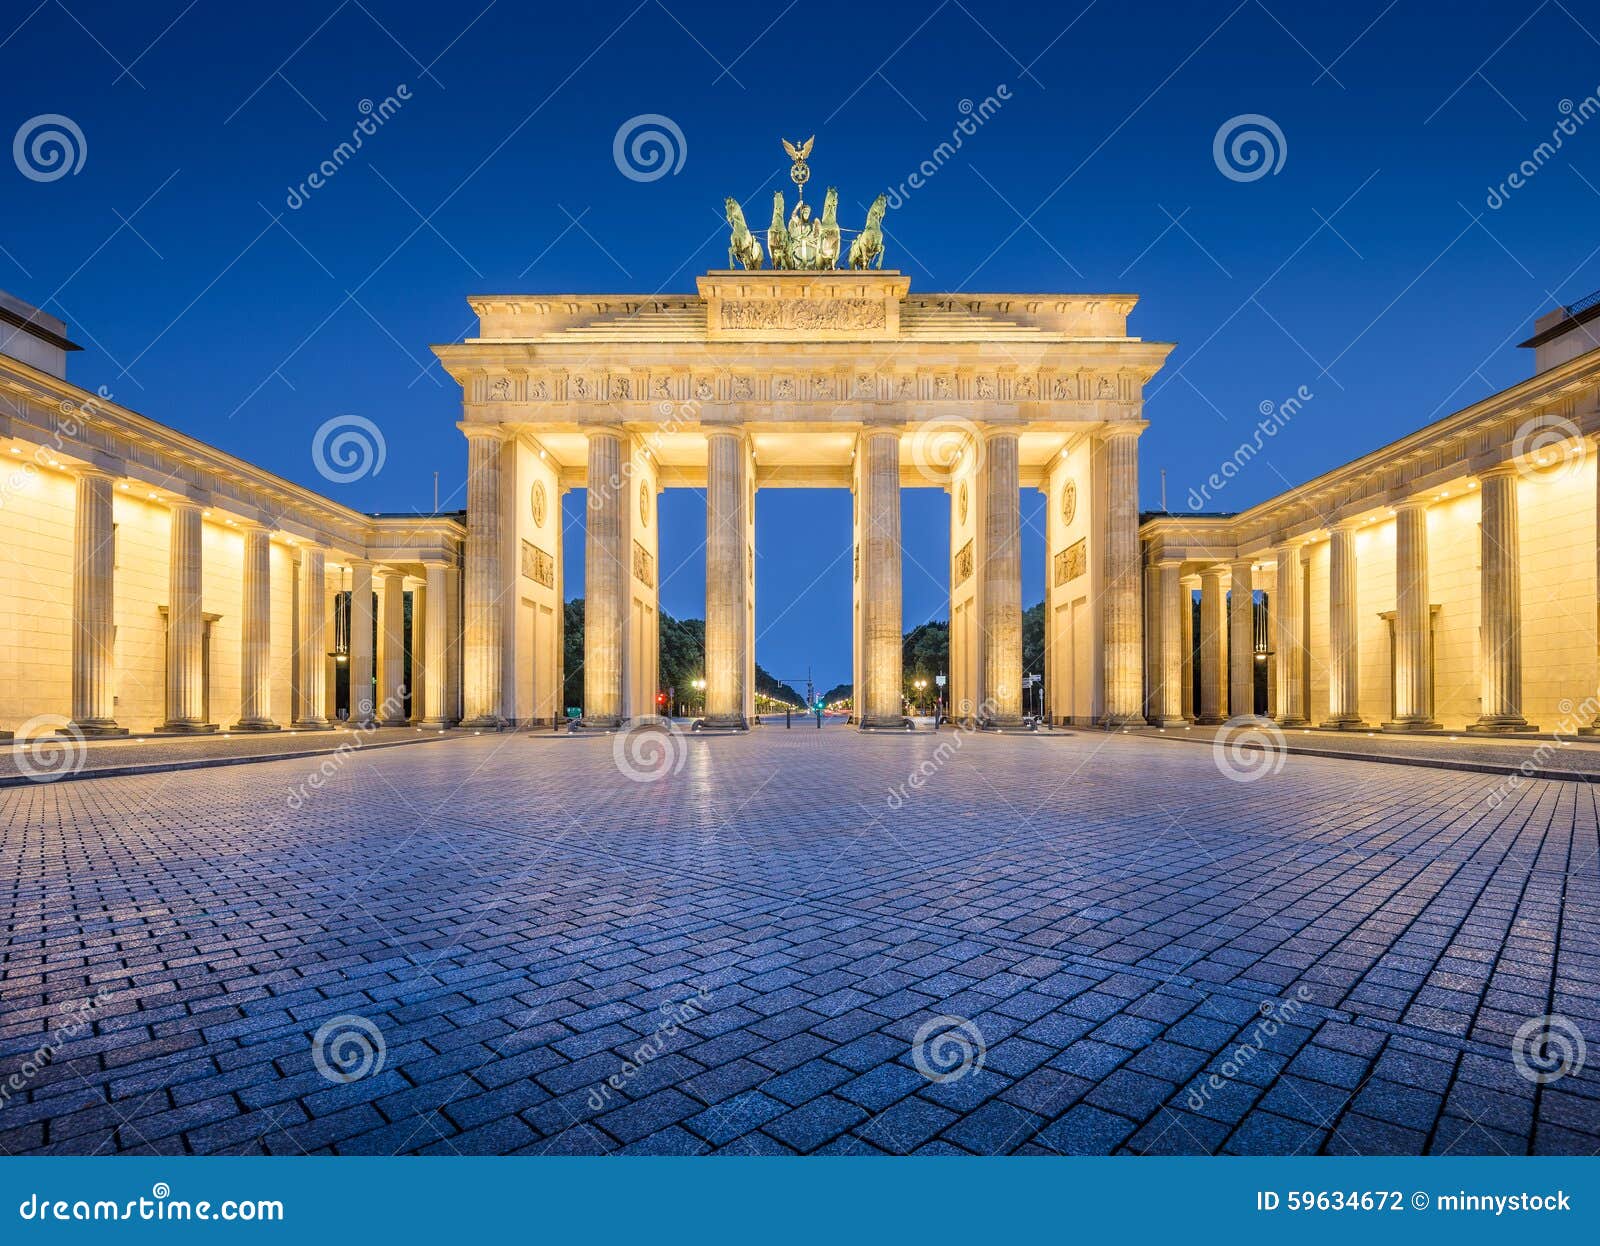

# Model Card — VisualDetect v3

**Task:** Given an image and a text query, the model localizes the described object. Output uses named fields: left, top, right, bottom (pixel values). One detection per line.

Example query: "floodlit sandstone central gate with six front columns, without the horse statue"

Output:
left=435, top=270, right=1171, bottom=728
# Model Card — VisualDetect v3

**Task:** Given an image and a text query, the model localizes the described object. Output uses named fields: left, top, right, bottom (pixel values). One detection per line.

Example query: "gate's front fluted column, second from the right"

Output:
left=978, top=429, right=1022, bottom=728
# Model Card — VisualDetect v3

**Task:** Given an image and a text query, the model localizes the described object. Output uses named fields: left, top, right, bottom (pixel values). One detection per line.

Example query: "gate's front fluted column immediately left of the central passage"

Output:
left=706, top=429, right=750, bottom=728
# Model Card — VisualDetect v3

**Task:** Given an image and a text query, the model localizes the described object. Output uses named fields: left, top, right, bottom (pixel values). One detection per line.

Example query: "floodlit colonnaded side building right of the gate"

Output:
left=1141, top=299, right=1600, bottom=734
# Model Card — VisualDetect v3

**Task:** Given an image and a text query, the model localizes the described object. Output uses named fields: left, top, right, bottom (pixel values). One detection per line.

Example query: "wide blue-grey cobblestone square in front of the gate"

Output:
left=0, top=728, right=1600, bottom=1155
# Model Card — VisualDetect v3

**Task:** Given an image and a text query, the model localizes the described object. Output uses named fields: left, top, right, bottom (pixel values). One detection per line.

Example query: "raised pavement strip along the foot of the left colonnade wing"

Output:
left=0, top=726, right=464, bottom=784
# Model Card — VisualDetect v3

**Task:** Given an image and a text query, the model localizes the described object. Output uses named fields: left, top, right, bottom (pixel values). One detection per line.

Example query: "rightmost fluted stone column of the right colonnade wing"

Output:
left=1467, top=462, right=1533, bottom=731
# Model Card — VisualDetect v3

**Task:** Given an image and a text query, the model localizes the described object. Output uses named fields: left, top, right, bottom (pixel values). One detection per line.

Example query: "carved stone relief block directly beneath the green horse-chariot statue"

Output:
left=698, top=270, right=910, bottom=342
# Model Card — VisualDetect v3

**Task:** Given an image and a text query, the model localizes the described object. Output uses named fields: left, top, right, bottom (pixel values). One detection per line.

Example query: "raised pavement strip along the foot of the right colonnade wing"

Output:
left=1134, top=726, right=1600, bottom=782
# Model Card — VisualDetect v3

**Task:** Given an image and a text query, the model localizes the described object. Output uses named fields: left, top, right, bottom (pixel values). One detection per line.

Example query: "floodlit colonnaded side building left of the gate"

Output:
left=0, top=294, right=467, bottom=737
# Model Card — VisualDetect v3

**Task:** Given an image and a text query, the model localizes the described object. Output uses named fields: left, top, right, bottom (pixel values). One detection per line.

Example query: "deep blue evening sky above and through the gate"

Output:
left=0, top=0, right=1600, bottom=683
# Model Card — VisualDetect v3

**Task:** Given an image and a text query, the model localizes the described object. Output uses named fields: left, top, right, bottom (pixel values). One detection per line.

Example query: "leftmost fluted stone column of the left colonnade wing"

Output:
left=72, top=467, right=128, bottom=736
